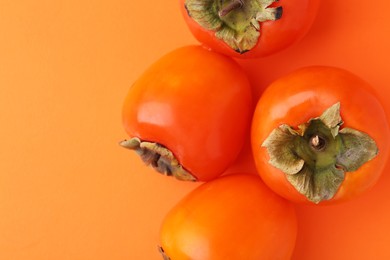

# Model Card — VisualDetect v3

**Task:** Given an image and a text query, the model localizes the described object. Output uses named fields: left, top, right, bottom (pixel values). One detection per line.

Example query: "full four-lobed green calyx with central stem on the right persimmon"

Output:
left=262, top=103, right=378, bottom=204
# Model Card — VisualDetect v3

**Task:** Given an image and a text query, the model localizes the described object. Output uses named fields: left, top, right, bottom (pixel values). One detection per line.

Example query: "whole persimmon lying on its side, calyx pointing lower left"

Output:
left=121, top=46, right=253, bottom=181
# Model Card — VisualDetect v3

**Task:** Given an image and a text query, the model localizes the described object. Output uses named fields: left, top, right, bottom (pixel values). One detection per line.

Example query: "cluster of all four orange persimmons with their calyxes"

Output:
left=121, top=0, right=390, bottom=260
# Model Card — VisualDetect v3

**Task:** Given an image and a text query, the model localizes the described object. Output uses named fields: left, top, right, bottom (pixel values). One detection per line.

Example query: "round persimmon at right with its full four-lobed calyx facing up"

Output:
left=251, top=66, right=390, bottom=204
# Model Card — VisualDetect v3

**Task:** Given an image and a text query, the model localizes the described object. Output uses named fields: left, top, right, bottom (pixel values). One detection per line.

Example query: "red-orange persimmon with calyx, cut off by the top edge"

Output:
left=180, top=0, right=320, bottom=58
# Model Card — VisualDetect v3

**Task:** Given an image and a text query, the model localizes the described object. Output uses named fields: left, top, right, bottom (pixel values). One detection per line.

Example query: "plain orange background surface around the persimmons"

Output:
left=0, top=0, right=390, bottom=260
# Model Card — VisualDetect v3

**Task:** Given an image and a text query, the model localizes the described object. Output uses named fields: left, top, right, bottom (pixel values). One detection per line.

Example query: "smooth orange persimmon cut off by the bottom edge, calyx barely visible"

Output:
left=160, top=173, right=297, bottom=260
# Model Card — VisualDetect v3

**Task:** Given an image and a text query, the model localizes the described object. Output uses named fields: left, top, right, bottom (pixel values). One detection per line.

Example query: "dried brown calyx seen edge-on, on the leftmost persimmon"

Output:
left=119, top=137, right=196, bottom=181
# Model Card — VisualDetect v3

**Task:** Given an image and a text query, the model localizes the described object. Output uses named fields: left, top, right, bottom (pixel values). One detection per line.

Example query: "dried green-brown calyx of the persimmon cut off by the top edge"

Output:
left=185, top=0, right=283, bottom=54
